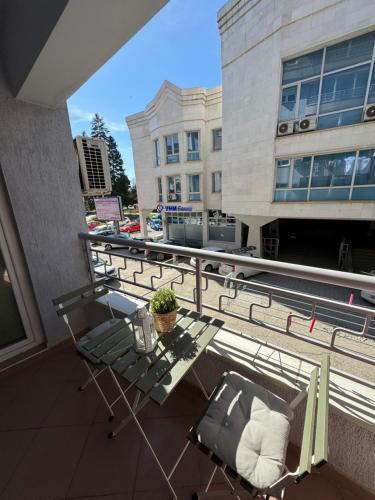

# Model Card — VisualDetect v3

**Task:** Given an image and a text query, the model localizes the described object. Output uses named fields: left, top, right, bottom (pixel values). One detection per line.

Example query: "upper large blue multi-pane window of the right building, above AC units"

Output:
left=279, top=32, right=375, bottom=129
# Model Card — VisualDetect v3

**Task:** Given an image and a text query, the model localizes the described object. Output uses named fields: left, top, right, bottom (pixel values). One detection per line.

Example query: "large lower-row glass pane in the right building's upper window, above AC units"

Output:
left=319, top=64, right=370, bottom=113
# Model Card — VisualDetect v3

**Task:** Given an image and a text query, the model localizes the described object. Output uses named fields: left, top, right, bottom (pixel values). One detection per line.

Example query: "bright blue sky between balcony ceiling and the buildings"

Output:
left=68, top=0, right=225, bottom=184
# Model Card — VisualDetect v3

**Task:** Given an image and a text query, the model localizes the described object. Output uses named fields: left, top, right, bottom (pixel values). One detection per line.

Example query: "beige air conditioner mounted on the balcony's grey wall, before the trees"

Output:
left=73, top=136, right=112, bottom=196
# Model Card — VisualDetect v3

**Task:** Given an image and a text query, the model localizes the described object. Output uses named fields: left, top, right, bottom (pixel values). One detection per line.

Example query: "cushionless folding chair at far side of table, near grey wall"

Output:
left=52, top=278, right=133, bottom=421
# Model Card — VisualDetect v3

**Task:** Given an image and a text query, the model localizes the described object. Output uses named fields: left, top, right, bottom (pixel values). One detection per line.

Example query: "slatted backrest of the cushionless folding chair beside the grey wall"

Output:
left=52, top=278, right=108, bottom=317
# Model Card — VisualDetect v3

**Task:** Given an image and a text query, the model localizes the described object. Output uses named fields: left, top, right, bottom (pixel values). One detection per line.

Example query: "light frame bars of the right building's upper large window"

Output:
left=277, top=31, right=375, bottom=130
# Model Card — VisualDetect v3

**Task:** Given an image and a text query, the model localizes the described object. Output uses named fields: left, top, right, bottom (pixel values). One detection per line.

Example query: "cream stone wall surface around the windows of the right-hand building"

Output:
left=218, top=0, right=375, bottom=219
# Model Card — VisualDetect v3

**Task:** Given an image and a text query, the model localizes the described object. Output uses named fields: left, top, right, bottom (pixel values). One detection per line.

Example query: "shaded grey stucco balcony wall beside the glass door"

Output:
left=0, top=68, right=89, bottom=345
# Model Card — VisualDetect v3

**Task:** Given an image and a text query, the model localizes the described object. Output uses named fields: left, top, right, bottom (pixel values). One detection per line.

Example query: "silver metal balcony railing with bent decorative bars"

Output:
left=79, top=233, right=375, bottom=364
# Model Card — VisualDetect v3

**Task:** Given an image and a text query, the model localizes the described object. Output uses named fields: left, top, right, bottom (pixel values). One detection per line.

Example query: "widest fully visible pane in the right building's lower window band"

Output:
left=310, top=152, right=355, bottom=188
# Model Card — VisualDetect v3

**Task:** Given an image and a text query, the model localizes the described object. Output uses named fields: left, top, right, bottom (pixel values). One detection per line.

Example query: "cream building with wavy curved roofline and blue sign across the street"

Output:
left=126, top=82, right=241, bottom=249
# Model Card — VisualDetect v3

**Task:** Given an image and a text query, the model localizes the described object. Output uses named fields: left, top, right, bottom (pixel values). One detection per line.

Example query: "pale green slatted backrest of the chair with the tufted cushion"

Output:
left=298, top=355, right=330, bottom=479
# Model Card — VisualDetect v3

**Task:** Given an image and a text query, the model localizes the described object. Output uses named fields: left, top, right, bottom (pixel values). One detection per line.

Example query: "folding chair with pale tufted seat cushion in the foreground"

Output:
left=188, top=356, right=329, bottom=499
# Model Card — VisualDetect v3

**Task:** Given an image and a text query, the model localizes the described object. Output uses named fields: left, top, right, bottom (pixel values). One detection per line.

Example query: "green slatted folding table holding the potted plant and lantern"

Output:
left=76, top=308, right=224, bottom=499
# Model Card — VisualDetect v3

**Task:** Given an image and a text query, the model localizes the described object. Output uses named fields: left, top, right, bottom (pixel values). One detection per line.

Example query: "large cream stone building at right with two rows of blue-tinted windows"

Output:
left=218, top=0, right=375, bottom=266
